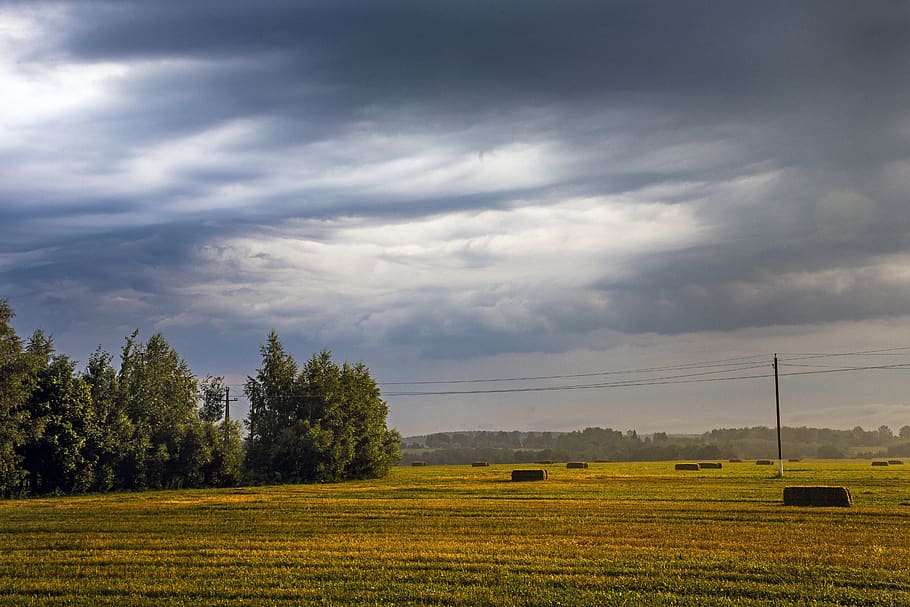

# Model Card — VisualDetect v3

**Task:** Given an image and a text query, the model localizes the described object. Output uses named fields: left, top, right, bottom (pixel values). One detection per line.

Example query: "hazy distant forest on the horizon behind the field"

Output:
left=402, top=426, right=910, bottom=464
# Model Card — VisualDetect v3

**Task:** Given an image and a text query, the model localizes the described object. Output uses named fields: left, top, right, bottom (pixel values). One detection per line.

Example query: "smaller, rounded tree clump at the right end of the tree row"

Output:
left=245, top=331, right=401, bottom=482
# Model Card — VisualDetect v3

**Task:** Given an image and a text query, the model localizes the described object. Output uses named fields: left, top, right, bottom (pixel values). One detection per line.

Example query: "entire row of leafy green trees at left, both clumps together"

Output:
left=0, top=300, right=400, bottom=497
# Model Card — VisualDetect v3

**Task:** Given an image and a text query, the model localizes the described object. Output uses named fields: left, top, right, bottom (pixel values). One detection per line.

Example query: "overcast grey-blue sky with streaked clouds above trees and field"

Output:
left=0, top=0, right=910, bottom=434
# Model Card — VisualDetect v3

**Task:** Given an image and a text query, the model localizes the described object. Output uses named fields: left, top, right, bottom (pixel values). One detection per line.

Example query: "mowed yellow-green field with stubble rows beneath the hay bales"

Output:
left=0, top=461, right=910, bottom=606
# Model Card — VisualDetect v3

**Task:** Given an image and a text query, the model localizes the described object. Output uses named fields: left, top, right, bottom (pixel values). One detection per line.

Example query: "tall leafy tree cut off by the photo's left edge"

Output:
left=0, top=300, right=35, bottom=497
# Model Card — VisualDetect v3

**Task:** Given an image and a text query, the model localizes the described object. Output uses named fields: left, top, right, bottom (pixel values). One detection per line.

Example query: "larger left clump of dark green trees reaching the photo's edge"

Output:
left=0, top=301, right=243, bottom=496
